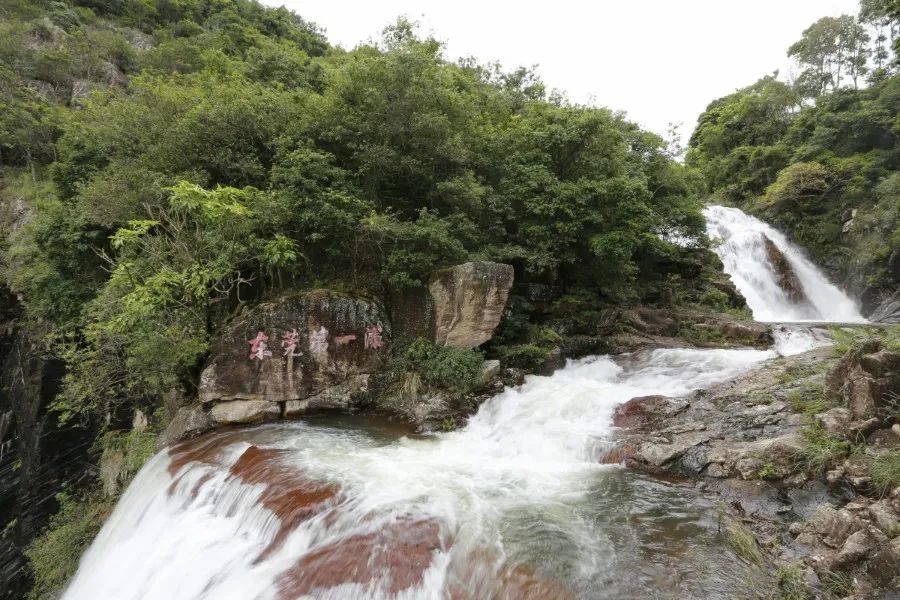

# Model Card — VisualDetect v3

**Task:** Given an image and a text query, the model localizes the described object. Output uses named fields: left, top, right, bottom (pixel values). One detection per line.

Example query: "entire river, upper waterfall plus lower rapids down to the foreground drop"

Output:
left=64, top=207, right=861, bottom=600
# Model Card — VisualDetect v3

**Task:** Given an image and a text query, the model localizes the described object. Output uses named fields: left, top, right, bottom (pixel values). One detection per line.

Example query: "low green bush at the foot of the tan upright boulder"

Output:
left=403, top=338, right=484, bottom=393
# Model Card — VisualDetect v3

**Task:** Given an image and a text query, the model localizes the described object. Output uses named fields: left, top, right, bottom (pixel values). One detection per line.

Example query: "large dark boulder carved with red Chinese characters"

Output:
left=199, top=291, right=390, bottom=424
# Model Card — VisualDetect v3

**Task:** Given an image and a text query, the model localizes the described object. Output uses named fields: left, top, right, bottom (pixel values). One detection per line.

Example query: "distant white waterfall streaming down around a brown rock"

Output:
left=704, top=206, right=865, bottom=323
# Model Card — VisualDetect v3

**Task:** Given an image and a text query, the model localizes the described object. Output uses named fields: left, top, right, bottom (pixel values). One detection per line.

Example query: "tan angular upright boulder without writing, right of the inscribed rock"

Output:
left=428, top=262, right=513, bottom=348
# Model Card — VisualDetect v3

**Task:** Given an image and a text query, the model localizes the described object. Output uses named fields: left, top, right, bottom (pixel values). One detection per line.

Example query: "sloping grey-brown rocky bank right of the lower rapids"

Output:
left=603, top=342, right=900, bottom=598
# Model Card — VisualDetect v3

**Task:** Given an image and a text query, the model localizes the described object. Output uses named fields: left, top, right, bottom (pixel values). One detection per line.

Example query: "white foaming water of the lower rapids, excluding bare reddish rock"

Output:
left=64, top=349, right=775, bottom=600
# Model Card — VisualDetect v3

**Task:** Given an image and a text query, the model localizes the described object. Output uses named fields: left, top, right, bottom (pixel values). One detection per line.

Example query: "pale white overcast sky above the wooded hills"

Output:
left=264, top=0, right=858, bottom=141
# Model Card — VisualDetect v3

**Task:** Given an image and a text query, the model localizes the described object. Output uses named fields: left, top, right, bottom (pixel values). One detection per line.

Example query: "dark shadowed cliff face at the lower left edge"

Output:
left=0, top=331, right=93, bottom=598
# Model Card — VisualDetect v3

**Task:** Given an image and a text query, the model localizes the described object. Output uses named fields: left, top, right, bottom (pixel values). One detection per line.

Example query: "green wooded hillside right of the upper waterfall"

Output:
left=687, top=0, right=900, bottom=314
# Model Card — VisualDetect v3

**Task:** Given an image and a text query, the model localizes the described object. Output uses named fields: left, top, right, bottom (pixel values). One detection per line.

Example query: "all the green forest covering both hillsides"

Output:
left=0, top=0, right=900, bottom=597
